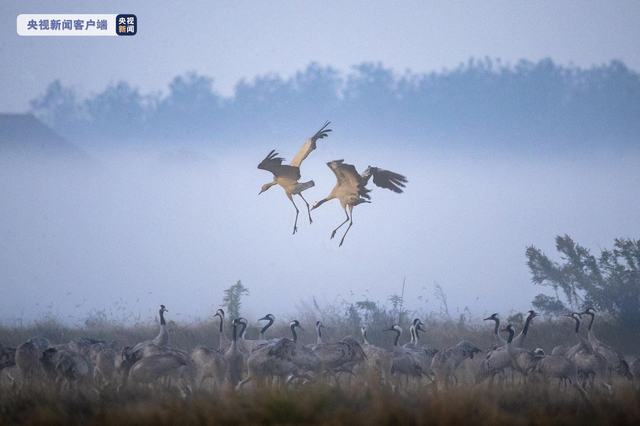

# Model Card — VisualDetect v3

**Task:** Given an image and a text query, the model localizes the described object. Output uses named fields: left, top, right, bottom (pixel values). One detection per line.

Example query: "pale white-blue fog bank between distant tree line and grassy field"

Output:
left=0, top=144, right=640, bottom=323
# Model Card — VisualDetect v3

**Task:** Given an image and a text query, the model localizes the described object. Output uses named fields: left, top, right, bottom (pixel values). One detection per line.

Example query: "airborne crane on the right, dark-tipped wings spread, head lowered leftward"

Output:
left=311, top=160, right=407, bottom=246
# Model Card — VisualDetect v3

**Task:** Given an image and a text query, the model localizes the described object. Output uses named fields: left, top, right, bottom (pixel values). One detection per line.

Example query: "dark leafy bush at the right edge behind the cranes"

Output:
left=526, top=235, right=640, bottom=330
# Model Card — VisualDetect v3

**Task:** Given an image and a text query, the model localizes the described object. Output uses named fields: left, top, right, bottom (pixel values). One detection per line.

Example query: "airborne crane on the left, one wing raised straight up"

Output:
left=258, top=121, right=331, bottom=234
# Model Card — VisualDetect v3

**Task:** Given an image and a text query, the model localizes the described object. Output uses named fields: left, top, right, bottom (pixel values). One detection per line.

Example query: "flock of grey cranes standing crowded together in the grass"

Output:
left=0, top=305, right=640, bottom=400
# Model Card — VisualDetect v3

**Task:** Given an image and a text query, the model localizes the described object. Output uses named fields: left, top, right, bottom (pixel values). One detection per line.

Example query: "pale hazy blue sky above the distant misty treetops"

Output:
left=0, top=0, right=640, bottom=112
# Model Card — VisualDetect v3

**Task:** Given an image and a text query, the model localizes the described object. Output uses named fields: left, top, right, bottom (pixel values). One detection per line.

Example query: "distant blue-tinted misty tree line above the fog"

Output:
left=30, top=59, right=640, bottom=148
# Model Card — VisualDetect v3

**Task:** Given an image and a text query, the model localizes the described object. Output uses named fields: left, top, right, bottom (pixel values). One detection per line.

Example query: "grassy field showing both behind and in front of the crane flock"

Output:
left=0, top=312, right=640, bottom=426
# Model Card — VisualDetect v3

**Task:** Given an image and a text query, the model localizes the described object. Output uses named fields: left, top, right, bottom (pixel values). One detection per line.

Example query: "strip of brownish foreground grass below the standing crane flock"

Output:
left=0, top=385, right=640, bottom=425
